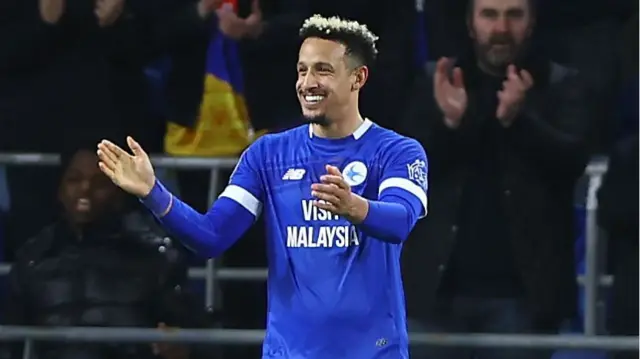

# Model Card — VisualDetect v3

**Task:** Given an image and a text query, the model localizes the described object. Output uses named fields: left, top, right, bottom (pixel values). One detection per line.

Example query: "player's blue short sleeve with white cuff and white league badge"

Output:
left=378, top=138, right=429, bottom=218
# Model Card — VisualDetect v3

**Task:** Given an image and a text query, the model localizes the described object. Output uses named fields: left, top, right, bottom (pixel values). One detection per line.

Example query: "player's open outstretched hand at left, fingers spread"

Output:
left=98, top=137, right=156, bottom=198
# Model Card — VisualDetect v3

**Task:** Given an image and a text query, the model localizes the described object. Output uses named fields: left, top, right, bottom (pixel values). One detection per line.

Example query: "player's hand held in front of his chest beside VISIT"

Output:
left=311, top=165, right=369, bottom=224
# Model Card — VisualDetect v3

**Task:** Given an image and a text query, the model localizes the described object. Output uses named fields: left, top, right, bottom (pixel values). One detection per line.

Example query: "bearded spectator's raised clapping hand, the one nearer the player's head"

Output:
left=433, top=57, right=467, bottom=128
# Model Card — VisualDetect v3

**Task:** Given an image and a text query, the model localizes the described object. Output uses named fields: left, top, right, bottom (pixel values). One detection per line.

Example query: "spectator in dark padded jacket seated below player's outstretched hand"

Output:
left=2, top=141, right=214, bottom=359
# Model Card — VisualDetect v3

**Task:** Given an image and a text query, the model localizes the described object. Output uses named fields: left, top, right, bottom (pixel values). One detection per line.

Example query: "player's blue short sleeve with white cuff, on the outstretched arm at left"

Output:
left=220, top=137, right=264, bottom=217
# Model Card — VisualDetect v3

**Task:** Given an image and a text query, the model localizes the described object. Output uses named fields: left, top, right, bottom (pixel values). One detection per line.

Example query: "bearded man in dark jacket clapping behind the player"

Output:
left=403, top=0, right=589, bottom=359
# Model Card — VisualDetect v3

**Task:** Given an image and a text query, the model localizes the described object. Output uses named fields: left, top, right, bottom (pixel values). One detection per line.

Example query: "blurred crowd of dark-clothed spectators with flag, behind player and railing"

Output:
left=0, top=0, right=639, bottom=359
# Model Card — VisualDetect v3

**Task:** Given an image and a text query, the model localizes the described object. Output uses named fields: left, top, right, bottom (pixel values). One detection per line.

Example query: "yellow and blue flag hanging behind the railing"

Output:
left=164, top=0, right=254, bottom=156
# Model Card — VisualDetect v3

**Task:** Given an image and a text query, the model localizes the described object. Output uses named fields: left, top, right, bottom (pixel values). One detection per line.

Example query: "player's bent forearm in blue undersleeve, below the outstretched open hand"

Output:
left=142, top=182, right=255, bottom=257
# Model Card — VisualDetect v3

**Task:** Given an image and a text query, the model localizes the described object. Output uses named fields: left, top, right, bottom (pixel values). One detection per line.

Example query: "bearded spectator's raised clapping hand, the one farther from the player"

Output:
left=496, top=65, right=533, bottom=127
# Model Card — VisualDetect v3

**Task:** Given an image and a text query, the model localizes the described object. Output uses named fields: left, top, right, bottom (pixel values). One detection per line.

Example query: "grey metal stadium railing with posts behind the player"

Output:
left=0, top=153, right=638, bottom=358
